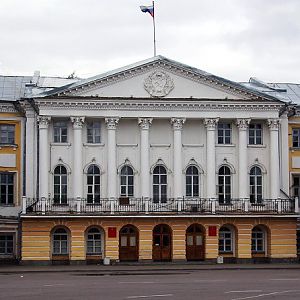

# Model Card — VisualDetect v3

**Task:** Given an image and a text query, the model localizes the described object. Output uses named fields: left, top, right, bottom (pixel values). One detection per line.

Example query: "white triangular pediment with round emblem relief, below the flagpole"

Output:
left=40, top=56, right=282, bottom=100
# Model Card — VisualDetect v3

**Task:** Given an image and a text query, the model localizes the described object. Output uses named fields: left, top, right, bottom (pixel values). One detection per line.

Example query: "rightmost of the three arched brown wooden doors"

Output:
left=186, top=224, right=205, bottom=260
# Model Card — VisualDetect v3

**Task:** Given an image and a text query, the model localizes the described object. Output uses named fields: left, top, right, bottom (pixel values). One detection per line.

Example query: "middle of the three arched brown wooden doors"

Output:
left=152, top=225, right=172, bottom=261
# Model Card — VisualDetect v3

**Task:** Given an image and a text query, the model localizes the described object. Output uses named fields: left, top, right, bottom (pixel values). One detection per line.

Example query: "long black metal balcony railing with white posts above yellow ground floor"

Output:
left=22, top=197, right=299, bottom=215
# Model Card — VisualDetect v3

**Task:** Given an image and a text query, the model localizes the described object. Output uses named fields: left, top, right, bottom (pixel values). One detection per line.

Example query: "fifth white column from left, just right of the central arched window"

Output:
left=171, top=118, right=185, bottom=198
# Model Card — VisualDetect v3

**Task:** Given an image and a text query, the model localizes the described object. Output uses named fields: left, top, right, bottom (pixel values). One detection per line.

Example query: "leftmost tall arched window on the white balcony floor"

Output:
left=54, top=165, right=68, bottom=204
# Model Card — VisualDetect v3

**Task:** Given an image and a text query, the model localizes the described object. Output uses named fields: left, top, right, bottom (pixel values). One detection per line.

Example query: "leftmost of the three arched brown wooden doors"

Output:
left=119, top=225, right=139, bottom=261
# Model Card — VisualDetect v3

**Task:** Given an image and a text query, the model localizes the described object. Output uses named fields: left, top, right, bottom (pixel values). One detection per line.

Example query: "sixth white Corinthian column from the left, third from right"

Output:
left=204, top=118, right=219, bottom=198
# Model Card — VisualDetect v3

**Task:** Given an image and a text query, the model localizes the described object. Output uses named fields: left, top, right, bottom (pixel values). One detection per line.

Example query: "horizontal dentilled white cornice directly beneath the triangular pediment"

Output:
left=36, top=99, right=282, bottom=111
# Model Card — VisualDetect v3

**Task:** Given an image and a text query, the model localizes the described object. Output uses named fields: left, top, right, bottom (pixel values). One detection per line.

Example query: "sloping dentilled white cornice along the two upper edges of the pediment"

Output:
left=58, top=61, right=267, bottom=99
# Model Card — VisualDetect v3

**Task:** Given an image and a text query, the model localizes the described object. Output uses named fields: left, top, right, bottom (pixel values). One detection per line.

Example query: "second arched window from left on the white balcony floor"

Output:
left=87, top=165, right=100, bottom=203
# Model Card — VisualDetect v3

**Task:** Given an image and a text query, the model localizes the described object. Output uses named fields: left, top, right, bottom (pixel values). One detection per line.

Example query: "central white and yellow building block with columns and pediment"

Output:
left=22, top=56, right=297, bottom=261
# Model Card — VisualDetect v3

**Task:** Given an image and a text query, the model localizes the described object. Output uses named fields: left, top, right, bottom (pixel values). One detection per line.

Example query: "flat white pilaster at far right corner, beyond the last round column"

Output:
left=280, top=112, right=289, bottom=194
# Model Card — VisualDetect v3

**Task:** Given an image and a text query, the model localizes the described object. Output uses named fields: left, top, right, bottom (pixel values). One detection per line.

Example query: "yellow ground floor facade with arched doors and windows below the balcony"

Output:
left=22, top=217, right=297, bottom=263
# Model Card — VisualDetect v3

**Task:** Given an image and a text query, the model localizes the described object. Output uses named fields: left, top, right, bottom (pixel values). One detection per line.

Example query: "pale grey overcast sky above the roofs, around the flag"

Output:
left=0, top=0, right=300, bottom=83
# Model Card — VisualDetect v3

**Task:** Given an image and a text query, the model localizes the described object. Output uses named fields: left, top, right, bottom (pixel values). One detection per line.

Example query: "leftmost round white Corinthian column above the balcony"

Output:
left=37, top=116, right=51, bottom=198
